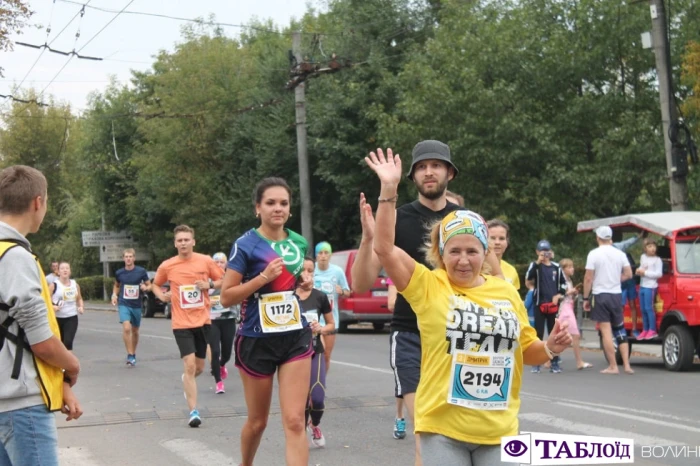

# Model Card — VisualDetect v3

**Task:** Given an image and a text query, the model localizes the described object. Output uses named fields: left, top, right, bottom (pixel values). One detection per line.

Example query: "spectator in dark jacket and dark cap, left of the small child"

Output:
left=525, top=239, right=567, bottom=374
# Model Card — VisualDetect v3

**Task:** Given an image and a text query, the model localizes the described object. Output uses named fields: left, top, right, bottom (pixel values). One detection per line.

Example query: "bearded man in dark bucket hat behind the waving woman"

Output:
left=352, top=140, right=501, bottom=465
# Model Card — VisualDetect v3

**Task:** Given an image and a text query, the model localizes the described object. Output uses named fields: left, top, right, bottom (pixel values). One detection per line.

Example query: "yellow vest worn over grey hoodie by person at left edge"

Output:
left=0, top=240, right=63, bottom=411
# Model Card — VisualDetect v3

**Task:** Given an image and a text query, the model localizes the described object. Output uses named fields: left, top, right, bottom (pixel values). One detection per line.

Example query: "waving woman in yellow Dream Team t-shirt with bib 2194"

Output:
left=362, top=154, right=571, bottom=466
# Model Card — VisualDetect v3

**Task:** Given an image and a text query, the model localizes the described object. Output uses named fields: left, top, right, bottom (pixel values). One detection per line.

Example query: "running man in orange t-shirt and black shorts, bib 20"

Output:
left=151, top=225, right=224, bottom=427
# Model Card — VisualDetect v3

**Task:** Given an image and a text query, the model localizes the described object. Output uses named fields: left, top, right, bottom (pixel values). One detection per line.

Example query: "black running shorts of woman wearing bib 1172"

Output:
left=234, top=327, right=314, bottom=378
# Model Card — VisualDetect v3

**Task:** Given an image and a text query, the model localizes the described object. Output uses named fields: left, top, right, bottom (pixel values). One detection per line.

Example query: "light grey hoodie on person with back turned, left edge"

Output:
left=0, top=222, right=53, bottom=412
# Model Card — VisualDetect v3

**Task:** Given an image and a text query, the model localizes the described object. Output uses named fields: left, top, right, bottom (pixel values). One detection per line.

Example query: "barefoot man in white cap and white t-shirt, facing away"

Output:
left=583, top=226, right=634, bottom=374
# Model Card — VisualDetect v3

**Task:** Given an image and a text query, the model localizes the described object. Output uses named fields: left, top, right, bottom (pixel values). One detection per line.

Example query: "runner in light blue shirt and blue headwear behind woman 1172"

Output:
left=314, top=241, right=350, bottom=371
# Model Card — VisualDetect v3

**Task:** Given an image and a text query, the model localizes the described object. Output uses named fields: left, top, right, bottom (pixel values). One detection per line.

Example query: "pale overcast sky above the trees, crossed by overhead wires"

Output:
left=0, top=0, right=318, bottom=112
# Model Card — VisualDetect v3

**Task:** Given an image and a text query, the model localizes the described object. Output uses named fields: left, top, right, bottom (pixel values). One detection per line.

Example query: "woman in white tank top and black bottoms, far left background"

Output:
left=51, top=262, right=83, bottom=351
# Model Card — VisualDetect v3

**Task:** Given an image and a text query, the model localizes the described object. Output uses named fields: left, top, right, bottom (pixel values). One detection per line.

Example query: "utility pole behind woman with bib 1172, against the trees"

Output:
left=292, top=31, right=314, bottom=248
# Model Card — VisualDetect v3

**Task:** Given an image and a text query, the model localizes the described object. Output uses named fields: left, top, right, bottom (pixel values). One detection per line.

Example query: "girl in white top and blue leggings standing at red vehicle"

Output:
left=636, top=238, right=663, bottom=340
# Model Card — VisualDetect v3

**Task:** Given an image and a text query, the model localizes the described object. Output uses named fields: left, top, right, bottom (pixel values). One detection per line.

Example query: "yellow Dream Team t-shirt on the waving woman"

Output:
left=401, top=264, right=537, bottom=445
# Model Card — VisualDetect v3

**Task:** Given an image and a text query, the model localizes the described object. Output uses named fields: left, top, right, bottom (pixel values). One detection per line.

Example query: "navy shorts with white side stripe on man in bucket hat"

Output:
left=390, top=331, right=420, bottom=398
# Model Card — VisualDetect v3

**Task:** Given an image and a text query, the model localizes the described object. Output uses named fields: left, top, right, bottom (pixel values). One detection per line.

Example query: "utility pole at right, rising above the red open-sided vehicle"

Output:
left=649, top=0, right=688, bottom=210
